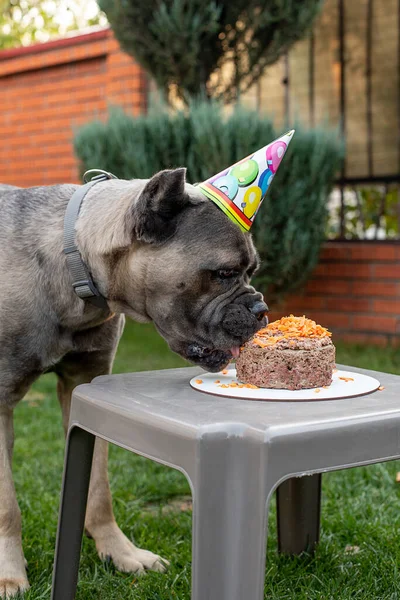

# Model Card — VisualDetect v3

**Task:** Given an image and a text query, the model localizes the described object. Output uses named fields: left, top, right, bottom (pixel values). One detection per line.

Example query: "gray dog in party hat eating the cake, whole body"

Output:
left=0, top=169, right=267, bottom=598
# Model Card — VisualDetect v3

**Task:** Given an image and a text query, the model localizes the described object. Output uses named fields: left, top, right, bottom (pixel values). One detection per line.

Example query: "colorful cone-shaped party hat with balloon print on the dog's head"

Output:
left=198, top=129, right=294, bottom=231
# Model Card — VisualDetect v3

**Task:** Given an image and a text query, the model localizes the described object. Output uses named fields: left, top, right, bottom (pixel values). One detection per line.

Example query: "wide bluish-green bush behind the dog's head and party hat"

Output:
left=74, top=102, right=342, bottom=300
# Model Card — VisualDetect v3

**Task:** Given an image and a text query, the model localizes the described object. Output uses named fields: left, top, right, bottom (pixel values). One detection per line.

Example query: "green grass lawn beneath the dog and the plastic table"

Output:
left=14, top=323, right=400, bottom=600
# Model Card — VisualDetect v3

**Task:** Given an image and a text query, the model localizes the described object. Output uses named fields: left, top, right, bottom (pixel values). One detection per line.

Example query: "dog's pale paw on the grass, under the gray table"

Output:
left=90, top=523, right=169, bottom=575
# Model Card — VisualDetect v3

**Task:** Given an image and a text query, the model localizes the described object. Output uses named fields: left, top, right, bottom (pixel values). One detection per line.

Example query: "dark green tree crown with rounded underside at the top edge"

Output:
left=98, top=0, right=323, bottom=102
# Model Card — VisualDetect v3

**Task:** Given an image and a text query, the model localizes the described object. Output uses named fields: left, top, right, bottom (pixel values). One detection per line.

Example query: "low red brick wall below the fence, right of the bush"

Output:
left=270, top=242, right=400, bottom=346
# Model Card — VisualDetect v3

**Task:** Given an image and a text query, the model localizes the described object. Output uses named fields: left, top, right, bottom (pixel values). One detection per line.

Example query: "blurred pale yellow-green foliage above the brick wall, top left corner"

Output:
left=0, top=0, right=106, bottom=50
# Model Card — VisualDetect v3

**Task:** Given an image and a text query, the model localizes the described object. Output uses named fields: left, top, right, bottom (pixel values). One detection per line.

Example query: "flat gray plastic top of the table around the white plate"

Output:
left=74, top=365, right=400, bottom=431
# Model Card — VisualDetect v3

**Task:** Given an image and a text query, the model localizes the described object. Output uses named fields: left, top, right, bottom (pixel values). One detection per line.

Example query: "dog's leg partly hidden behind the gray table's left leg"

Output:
left=58, top=373, right=168, bottom=573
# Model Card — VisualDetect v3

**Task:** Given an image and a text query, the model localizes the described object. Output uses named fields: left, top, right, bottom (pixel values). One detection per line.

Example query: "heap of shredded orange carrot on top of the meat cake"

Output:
left=253, top=315, right=332, bottom=348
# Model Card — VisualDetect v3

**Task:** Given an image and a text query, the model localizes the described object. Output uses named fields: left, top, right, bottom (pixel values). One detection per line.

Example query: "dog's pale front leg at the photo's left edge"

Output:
left=0, top=407, right=29, bottom=598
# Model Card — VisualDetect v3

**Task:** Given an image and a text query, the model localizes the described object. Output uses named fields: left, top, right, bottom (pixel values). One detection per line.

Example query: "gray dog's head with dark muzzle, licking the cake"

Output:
left=87, top=169, right=268, bottom=371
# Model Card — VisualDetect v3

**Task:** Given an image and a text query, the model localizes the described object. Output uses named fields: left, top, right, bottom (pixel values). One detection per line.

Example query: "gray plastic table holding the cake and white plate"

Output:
left=52, top=367, right=400, bottom=600
